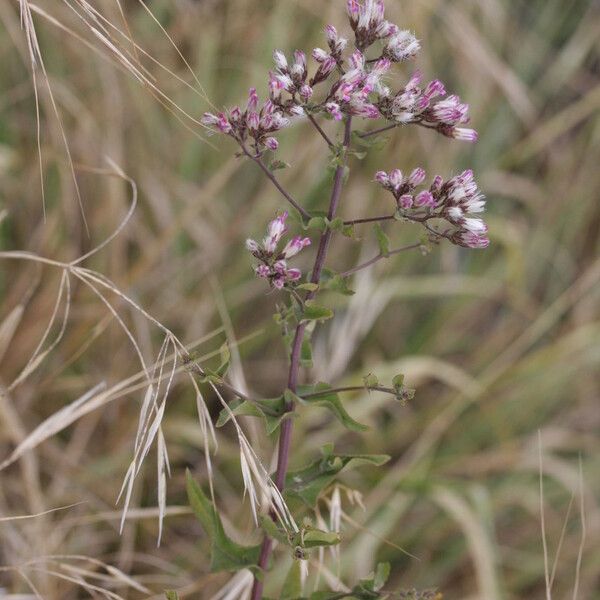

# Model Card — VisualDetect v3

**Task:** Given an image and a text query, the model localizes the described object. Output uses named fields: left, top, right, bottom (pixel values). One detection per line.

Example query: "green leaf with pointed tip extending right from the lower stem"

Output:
left=285, top=449, right=390, bottom=507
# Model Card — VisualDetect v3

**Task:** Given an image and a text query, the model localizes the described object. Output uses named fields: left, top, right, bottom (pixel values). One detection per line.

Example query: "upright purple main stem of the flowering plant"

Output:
left=251, top=117, right=352, bottom=600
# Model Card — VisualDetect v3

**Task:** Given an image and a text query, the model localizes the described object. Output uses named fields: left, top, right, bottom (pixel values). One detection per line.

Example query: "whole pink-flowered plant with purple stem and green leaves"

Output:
left=188, top=0, right=489, bottom=600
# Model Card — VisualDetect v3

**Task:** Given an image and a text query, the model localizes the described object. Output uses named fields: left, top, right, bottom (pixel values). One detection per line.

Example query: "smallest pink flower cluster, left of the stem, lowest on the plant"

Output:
left=246, top=212, right=310, bottom=290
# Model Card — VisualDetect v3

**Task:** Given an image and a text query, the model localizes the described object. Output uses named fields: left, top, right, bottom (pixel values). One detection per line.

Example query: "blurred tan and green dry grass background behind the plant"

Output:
left=0, top=0, right=600, bottom=600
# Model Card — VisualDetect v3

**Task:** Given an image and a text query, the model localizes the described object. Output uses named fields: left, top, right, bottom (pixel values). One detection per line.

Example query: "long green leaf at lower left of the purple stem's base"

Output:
left=186, top=470, right=260, bottom=572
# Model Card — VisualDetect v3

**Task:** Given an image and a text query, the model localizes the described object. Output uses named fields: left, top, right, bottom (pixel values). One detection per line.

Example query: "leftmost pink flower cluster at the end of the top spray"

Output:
left=202, top=88, right=301, bottom=151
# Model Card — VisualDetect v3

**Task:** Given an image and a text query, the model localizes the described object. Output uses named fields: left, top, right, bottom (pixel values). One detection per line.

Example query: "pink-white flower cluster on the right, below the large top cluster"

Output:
left=375, top=168, right=490, bottom=248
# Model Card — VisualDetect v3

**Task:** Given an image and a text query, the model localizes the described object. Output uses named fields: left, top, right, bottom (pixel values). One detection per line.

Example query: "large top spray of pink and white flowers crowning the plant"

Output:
left=203, top=0, right=477, bottom=149
